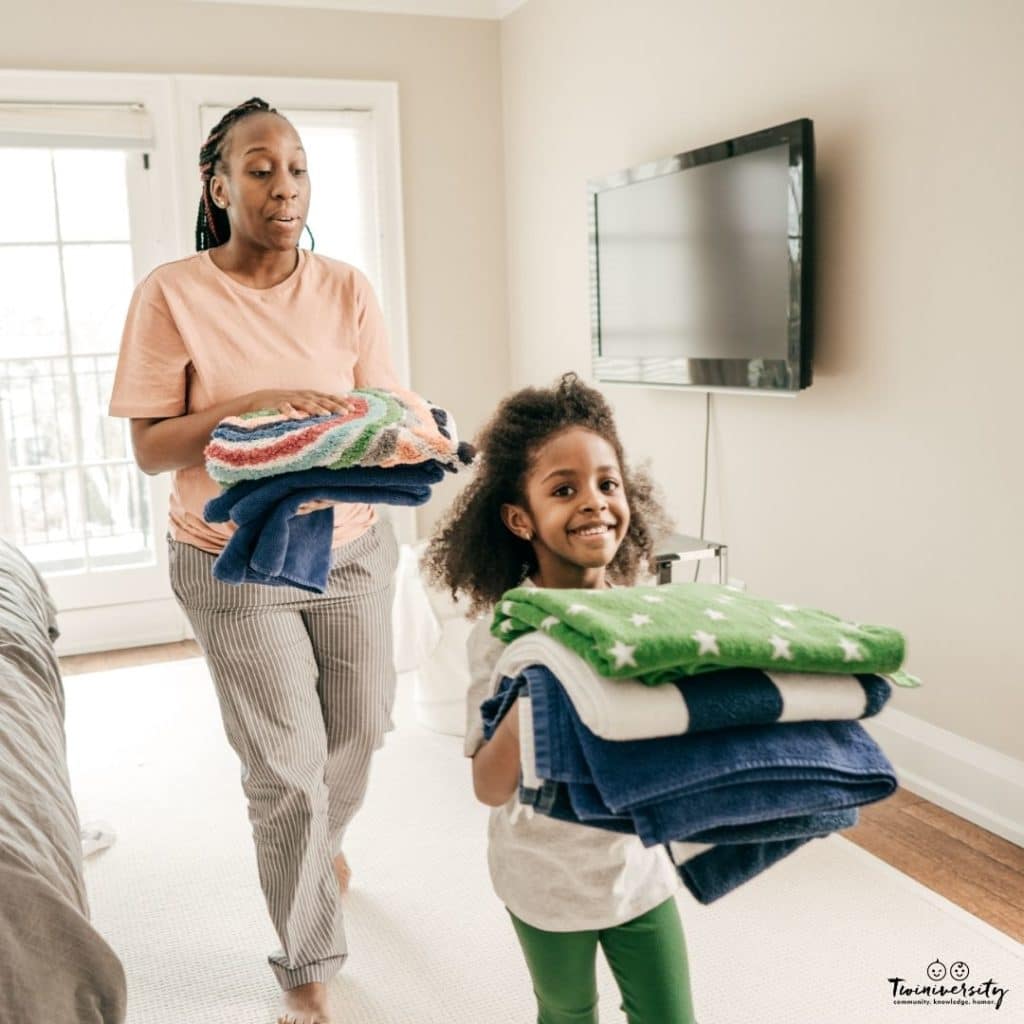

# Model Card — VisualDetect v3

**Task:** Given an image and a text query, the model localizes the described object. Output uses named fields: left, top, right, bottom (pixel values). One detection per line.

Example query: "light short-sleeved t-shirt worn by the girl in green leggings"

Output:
left=465, top=616, right=680, bottom=932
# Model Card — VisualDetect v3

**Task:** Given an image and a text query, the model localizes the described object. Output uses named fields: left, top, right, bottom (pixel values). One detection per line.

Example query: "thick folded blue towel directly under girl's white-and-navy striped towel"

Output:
left=522, top=666, right=896, bottom=846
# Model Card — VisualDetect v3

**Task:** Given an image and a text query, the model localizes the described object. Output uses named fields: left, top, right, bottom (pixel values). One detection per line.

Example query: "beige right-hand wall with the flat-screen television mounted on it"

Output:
left=502, top=0, right=1024, bottom=758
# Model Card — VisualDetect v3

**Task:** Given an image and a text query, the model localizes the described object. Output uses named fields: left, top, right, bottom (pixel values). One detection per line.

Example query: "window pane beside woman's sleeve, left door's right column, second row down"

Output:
left=63, top=244, right=133, bottom=352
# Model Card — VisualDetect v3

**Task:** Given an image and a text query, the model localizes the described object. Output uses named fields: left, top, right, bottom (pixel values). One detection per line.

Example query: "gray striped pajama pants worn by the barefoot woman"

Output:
left=169, top=522, right=397, bottom=988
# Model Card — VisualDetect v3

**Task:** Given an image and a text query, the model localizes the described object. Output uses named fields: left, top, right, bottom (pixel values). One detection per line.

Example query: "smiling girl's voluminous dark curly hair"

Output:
left=422, top=373, right=670, bottom=614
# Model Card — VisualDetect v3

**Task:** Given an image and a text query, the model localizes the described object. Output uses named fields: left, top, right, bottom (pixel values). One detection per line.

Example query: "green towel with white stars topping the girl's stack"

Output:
left=490, top=583, right=904, bottom=685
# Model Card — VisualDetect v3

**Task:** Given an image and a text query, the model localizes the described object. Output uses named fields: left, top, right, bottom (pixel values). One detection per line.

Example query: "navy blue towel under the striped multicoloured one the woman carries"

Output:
left=203, top=462, right=444, bottom=593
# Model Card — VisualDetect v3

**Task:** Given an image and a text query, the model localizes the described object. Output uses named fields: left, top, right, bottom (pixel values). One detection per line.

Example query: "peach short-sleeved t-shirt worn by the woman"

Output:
left=109, top=249, right=398, bottom=552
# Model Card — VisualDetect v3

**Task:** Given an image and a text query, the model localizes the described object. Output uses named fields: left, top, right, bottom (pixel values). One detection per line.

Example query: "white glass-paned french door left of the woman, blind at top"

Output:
left=0, top=72, right=184, bottom=652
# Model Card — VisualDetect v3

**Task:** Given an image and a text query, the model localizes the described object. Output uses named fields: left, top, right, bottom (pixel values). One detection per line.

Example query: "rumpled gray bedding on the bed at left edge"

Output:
left=0, top=539, right=125, bottom=1024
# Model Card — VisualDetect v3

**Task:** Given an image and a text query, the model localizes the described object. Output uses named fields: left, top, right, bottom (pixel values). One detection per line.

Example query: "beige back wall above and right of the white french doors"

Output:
left=0, top=0, right=508, bottom=529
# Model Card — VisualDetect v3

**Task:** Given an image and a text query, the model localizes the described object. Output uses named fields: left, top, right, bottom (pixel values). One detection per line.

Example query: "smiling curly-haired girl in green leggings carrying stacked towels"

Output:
left=424, top=374, right=693, bottom=1024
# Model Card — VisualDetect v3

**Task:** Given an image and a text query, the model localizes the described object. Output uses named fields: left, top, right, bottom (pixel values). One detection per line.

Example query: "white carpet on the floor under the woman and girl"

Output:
left=66, top=659, right=1024, bottom=1024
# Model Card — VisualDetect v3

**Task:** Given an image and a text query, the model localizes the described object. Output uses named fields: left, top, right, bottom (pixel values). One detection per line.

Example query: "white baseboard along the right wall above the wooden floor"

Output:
left=862, top=708, right=1024, bottom=847
